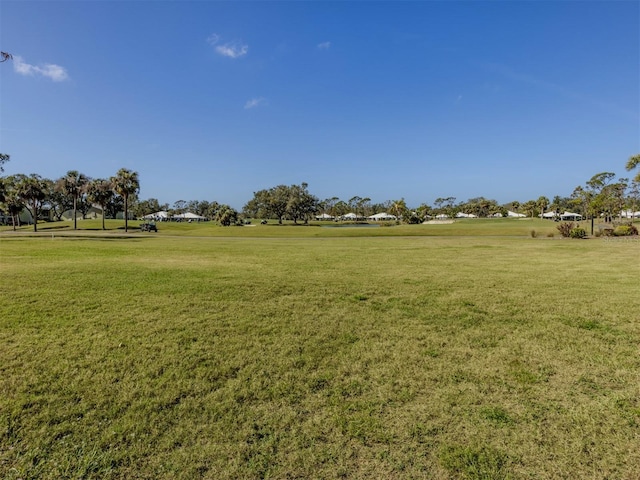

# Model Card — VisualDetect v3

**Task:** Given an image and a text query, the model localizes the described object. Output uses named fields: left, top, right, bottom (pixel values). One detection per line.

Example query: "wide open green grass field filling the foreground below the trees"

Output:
left=0, top=220, right=640, bottom=479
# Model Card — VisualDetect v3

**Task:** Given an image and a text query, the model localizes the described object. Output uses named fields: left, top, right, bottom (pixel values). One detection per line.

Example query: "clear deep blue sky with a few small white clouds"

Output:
left=0, top=0, right=640, bottom=209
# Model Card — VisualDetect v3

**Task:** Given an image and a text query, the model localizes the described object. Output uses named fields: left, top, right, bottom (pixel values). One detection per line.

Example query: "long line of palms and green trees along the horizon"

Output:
left=0, top=154, right=640, bottom=231
